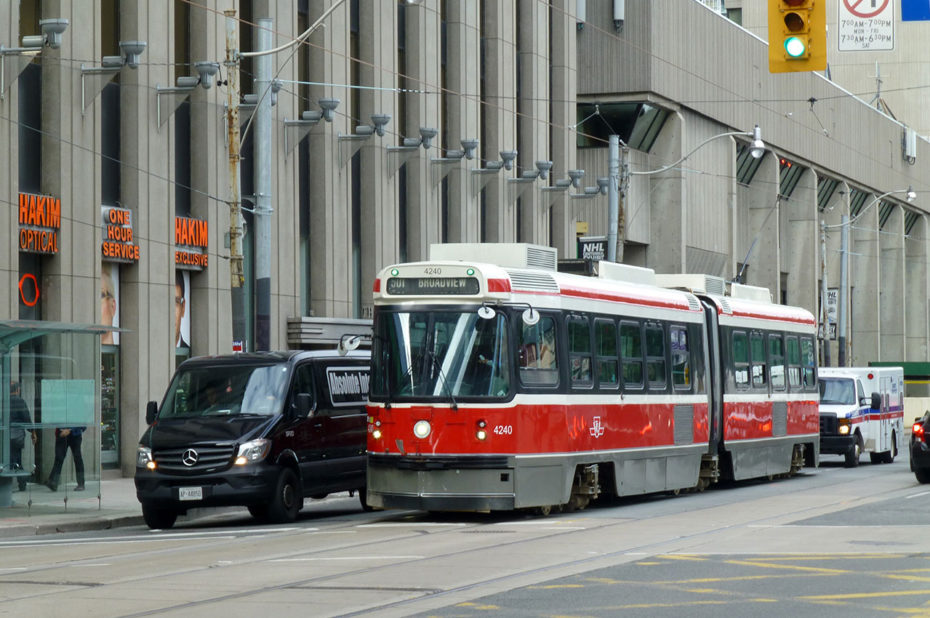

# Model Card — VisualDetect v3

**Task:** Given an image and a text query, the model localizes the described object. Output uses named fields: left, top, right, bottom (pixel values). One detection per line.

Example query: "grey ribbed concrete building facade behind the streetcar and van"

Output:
left=0, top=0, right=930, bottom=475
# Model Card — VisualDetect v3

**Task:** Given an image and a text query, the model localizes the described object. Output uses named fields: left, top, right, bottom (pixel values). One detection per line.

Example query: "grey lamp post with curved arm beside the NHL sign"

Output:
left=607, top=125, right=765, bottom=262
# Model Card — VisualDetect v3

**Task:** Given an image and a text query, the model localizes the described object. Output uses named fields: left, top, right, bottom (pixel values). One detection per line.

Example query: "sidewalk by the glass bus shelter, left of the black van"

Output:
left=0, top=478, right=144, bottom=538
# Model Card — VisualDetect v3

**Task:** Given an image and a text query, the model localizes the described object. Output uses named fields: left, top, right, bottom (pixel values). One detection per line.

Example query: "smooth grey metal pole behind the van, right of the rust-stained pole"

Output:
left=254, top=17, right=272, bottom=351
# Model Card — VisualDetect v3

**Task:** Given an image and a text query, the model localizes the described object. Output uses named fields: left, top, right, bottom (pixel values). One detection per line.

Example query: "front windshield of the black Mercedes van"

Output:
left=158, top=364, right=288, bottom=419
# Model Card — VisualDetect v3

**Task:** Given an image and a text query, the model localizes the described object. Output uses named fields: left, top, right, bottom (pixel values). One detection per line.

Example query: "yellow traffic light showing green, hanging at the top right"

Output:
left=767, top=0, right=827, bottom=73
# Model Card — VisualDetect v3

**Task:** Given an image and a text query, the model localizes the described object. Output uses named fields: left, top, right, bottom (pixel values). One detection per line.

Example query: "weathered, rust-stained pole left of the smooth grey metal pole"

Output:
left=223, top=10, right=248, bottom=351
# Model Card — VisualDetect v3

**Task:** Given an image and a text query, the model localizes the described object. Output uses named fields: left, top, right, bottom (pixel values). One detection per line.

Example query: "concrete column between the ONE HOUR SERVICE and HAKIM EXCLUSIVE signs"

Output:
left=118, top=2, right=175, bottom=476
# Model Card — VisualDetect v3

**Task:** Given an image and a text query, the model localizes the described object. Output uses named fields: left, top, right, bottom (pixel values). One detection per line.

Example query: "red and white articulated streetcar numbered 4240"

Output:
left=367, top=244, right=820, bottom=513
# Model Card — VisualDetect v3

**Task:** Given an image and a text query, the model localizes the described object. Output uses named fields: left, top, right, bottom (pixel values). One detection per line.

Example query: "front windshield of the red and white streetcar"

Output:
left=371, top=310, right=511, bottom=402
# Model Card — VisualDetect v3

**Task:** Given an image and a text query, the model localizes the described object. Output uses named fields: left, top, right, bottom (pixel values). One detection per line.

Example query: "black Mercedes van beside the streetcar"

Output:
left=135, top=351, right=370, bottom=528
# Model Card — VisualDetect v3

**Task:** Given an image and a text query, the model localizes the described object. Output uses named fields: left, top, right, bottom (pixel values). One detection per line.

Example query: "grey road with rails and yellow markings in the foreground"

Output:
left=0, top=457, right=930, bottom=618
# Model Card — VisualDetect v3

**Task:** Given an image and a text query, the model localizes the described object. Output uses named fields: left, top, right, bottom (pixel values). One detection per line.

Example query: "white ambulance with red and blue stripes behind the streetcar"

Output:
left=818, top=367, right=904, bottom=468
